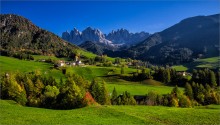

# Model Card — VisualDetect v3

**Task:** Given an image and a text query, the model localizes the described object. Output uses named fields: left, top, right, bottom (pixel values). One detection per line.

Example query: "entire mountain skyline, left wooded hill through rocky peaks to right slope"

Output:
left=1, top=14, right=220, bottom=65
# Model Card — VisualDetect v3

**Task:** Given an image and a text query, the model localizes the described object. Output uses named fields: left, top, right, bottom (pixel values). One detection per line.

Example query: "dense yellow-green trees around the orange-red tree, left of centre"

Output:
left=0, top=71, right=136, bottom=109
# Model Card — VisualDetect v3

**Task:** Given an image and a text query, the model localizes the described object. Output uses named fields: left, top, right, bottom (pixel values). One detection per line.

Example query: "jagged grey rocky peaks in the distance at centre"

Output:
left=62, top=27, right=149, bottom=47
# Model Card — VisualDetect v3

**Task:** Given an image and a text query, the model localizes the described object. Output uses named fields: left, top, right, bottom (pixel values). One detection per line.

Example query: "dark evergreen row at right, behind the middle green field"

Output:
left=120, top=66, right=220, bottom=87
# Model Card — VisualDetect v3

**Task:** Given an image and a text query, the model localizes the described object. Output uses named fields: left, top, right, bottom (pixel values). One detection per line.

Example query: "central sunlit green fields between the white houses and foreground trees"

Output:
left=67, top=66, right=180, bottom=95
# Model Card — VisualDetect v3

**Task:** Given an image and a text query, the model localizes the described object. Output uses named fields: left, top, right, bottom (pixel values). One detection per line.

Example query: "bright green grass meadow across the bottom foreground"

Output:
left=0, top=100, right=220, bottom=125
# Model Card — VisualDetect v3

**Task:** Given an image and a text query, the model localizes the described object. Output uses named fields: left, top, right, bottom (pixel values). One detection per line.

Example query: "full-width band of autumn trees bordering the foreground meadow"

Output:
left=0, top=69, right=220, bottom=109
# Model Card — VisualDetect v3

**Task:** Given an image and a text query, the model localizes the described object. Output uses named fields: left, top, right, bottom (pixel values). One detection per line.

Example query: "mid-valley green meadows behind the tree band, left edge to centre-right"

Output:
left=0, top=56, right=183, bottom=95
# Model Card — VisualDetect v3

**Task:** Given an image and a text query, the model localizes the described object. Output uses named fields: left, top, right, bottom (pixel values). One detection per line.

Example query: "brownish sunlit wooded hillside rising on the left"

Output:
left=0, top=14, right=79, bottom=57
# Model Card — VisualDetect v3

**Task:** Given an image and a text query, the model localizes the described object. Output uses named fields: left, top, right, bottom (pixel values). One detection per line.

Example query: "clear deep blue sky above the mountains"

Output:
left=1, top=0, right=220, bottom=36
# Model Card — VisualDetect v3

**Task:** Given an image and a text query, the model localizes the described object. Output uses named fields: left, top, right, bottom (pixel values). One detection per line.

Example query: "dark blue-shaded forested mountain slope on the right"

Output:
left=126, top=14, right=220, bottom=64
